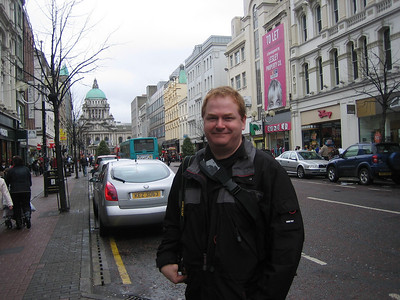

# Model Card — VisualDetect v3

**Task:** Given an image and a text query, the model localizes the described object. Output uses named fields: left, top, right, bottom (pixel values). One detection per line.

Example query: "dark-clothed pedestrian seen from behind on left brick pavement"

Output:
left=5, top=156, right=32, bottom=229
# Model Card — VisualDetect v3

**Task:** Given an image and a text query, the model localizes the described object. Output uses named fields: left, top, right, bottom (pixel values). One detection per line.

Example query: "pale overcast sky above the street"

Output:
left=26, top=0, right=244, bottom=123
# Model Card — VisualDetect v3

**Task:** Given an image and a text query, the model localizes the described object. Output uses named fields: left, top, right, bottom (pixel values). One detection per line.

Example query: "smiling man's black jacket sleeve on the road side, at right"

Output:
left=255, top=158, right=304, bottom=299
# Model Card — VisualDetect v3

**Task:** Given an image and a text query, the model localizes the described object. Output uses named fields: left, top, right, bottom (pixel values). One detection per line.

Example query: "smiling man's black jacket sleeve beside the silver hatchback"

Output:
left=156, top=165, right=182, bottom=269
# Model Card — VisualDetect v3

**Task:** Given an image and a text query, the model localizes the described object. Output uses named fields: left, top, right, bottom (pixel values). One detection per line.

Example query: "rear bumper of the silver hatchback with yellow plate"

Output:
left=102, top=205, right=167, bottom=227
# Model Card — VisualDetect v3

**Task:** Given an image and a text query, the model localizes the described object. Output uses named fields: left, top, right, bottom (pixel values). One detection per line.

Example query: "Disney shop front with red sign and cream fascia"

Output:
left=299, top=105, right=342, bottom=150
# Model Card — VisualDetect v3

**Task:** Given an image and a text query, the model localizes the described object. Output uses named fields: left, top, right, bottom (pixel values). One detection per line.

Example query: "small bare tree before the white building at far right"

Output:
left=356, top=51, right=400, bottom=142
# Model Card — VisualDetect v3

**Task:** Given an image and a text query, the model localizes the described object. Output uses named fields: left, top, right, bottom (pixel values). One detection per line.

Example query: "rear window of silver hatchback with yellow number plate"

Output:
left=111, top=163, right=170, bottom=183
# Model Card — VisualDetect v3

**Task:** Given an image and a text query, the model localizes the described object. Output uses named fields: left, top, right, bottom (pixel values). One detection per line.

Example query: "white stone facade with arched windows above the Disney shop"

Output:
left=290, top=0, right=400, bottom=148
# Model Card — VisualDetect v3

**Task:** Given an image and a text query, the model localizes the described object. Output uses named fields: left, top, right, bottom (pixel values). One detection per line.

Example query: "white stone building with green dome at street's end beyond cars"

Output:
left=79, top=79, right=132, bottom=155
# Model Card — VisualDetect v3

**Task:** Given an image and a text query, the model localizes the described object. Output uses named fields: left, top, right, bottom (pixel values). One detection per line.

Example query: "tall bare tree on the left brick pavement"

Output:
left=22, top=0, right=110, bottom=212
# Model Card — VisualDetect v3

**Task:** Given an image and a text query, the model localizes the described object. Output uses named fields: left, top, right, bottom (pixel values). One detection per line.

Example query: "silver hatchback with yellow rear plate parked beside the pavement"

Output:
left=93, top=159, right=175, bottom=236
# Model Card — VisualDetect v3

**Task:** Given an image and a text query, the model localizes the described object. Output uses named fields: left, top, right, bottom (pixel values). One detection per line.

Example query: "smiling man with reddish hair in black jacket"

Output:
left=156, top=87, right=304, bottom=300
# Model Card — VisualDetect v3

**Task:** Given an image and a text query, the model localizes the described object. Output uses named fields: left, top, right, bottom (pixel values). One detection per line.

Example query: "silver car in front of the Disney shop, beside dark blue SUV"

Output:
left=276, top=150, right=328, bottom=178
